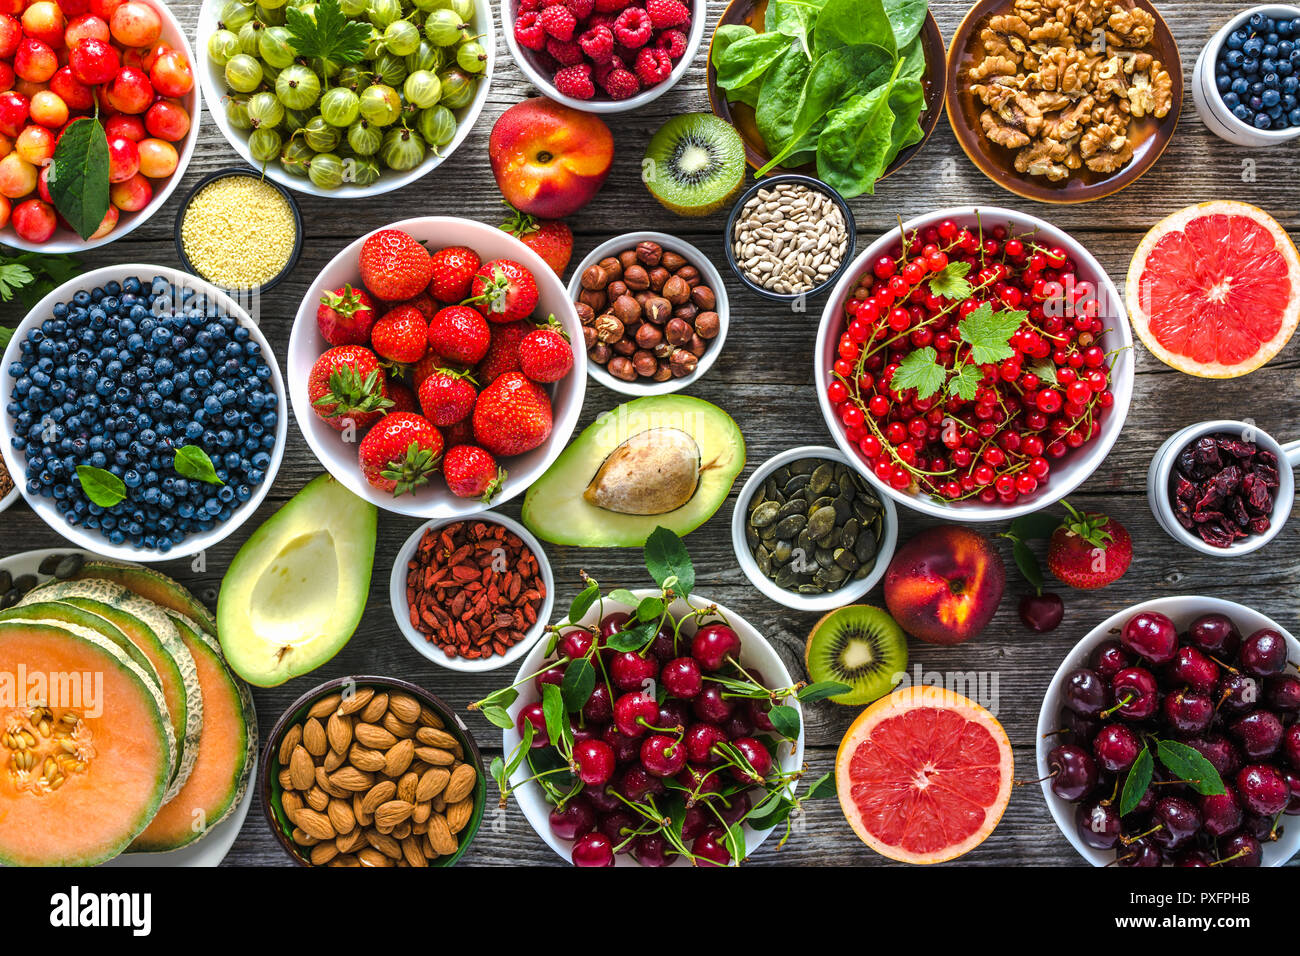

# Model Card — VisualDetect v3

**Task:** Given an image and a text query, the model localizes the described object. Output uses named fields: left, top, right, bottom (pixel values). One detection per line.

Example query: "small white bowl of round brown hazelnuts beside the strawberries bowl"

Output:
left=569, top=232, right=729, bottom=395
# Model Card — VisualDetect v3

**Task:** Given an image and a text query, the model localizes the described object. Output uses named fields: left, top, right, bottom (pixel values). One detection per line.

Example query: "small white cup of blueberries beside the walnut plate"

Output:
left=1192, top=4, right=1300, bottom=147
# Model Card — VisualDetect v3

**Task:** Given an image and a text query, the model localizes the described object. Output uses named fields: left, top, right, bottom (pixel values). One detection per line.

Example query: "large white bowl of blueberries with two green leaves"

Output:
left=0, top=264, right=287, bottom=562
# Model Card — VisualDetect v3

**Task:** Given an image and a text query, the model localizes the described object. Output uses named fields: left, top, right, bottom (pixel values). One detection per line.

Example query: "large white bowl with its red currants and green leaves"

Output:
left=815, top=207, right=1134, bottom=522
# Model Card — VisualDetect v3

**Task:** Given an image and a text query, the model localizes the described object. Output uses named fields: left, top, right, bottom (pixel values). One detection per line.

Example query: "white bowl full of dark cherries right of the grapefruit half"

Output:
left=1037, top=596, right=1300, bottom=866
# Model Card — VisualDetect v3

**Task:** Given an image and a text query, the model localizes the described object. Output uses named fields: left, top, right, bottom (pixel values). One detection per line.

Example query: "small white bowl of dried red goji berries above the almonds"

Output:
left=389, top=512, right=555, bottom=671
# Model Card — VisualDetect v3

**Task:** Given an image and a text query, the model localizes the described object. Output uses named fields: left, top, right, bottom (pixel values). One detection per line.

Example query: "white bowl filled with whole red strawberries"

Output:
left=289, top=216, right=586, bottom=518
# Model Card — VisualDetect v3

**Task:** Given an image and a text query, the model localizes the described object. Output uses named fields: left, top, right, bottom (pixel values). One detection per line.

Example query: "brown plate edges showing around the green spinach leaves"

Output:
left=709, top=0, right=946, bottom=179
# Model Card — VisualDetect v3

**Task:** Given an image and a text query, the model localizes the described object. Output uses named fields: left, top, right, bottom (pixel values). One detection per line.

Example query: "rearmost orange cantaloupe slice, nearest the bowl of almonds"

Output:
left=130, top=613, right=257, bottom=852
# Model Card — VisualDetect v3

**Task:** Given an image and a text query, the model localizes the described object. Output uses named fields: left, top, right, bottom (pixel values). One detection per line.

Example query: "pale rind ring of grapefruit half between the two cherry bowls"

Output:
left=835, top=687, right=1014, bottom=864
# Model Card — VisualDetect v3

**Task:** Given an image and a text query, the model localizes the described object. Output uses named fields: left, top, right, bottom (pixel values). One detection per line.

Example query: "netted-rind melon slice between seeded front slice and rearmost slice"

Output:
left=18, top=579, right=203, bottom=800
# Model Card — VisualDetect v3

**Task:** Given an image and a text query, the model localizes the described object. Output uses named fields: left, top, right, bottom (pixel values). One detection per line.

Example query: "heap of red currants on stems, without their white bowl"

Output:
left=827, top=220, right=1114, bottom=505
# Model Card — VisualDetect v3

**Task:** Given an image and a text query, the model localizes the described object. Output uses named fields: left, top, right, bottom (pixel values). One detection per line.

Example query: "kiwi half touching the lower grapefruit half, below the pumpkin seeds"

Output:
left=803, top=604, right=907, bottom=704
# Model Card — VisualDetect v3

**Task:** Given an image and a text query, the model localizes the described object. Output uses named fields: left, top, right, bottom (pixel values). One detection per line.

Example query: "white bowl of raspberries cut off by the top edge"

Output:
left=501, top=0, right=707, bottom=113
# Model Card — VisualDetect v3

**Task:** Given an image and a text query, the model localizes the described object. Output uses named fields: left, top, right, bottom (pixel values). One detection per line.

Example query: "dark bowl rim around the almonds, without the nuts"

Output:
left=257, top=675, right=488, bottom=866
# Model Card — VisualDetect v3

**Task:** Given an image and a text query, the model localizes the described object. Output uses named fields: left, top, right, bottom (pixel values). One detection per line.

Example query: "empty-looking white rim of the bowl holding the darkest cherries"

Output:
left=1036, top=594, right=1300, bottom=866
